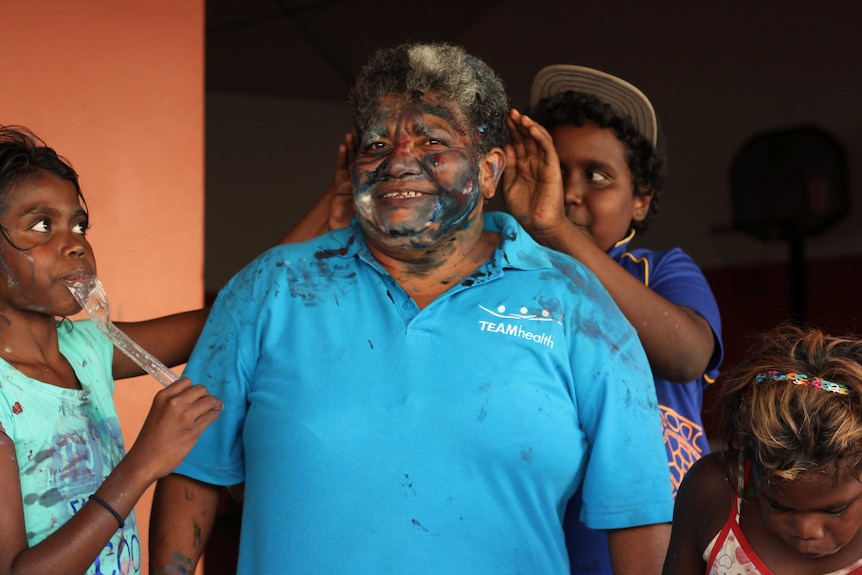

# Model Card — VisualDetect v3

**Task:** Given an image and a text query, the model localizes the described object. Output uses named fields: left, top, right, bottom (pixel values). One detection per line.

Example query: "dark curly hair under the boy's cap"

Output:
left=529, top=90, right=667, bottom=233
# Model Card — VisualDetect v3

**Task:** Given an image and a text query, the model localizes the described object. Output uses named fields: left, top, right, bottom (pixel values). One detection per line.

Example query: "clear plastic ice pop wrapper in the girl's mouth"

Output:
left=66, top=276, right=179, bottom=387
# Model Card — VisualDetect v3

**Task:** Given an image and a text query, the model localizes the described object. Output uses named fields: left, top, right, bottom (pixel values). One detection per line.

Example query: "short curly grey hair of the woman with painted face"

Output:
left=349, top=43, right=509, bottom=153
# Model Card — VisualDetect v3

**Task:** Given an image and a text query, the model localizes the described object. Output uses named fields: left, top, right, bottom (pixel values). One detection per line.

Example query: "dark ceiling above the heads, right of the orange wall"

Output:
left=205, top=0, right=859, bottom=116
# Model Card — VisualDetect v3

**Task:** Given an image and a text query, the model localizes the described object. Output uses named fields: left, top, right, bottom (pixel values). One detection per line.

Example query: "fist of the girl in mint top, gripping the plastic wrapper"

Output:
left=129, top=377, right=224, bottom=481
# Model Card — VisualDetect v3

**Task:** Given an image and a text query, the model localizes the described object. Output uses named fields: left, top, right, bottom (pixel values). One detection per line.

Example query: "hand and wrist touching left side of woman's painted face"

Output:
left=278, top=132, right=356, bottom=244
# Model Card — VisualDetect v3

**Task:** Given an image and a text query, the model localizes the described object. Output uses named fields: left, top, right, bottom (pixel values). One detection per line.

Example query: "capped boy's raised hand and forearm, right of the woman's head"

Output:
left=503, top=110, right=715, bottom=383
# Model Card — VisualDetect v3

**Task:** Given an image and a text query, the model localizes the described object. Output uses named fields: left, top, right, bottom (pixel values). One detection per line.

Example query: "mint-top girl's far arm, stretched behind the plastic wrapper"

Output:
left=111, top=308, right=209, bottom=379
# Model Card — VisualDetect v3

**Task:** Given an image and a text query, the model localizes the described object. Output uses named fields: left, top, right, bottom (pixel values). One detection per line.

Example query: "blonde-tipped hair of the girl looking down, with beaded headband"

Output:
left=718, top=325, right=862, bottom=481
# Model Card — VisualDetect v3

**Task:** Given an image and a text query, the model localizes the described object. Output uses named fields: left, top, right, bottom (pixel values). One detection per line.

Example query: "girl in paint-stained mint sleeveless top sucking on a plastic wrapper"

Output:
left=0, top=126, right=221, bottom=574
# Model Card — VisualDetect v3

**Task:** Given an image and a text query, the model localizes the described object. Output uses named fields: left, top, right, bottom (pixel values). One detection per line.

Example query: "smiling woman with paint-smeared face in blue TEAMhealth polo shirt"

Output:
left=150, top=44, right=672, bottom=574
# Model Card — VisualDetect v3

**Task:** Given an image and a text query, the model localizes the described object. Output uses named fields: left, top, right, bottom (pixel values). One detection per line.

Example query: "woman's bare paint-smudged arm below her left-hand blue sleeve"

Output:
left=149, top=474, right=221, bottom=575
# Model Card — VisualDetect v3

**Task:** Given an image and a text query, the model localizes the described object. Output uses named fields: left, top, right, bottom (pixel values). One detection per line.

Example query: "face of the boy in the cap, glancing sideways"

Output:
left=549, top=124, right=652, bottom=252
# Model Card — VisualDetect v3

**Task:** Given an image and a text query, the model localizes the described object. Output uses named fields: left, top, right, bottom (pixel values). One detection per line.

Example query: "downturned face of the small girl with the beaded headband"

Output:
left=754, top=468, right=862, bottom=559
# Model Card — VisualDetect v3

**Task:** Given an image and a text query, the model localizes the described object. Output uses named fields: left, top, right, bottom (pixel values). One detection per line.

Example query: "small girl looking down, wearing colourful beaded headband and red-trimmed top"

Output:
left=663, top=325, right=862, bottom=575
